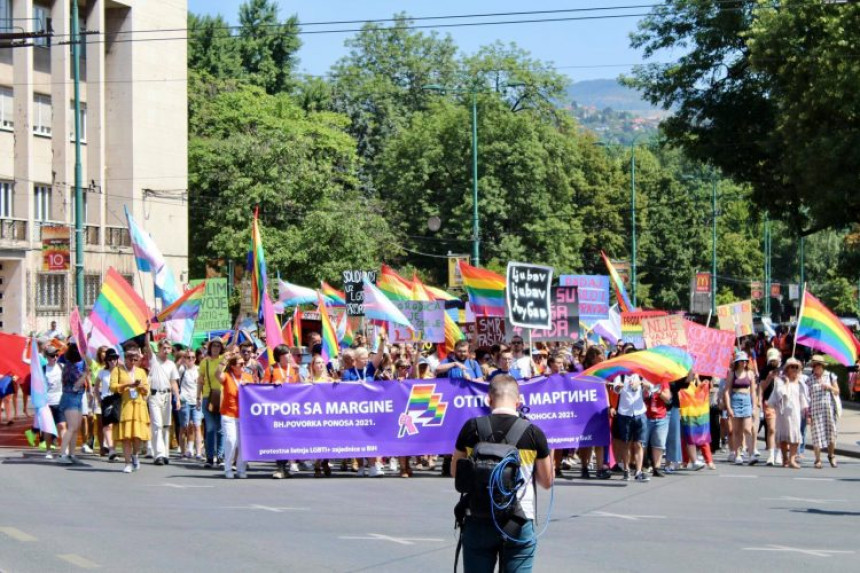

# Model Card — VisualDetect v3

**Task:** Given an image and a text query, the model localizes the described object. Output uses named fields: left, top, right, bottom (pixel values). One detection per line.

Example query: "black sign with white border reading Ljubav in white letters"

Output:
left=505, top=262, right=553, bottom=329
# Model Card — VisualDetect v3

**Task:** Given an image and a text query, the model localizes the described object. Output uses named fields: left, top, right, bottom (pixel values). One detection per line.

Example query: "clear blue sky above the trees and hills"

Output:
left=188, top=0, right=649, bottom=81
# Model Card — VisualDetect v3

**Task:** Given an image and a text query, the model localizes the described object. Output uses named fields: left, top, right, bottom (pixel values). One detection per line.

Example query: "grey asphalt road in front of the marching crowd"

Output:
left=0, top=449, right=860, bottom=573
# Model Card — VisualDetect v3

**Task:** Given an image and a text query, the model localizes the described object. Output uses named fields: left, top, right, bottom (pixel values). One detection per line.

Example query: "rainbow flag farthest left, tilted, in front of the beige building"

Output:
left=90, top=267, right=152, bottom=346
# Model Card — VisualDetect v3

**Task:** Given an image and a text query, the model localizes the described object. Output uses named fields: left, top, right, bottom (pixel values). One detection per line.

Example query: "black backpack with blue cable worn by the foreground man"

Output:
left=454, top=416, right=531, bottom=525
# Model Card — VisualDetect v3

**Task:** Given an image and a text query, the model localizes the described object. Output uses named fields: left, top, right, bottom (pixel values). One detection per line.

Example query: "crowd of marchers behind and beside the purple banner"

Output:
left=3, top=322, right=860, bottom=482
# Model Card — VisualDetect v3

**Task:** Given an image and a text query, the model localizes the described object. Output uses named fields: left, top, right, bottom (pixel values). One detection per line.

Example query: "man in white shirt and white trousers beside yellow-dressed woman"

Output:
left=145, top=340, right=181, bottom=466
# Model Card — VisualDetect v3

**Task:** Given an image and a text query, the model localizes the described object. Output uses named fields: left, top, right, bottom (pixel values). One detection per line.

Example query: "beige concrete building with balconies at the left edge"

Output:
left=0, top=0, right=188, bottom=333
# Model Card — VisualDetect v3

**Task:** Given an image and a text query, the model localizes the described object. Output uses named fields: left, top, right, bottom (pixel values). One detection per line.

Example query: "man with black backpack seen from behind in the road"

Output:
left=451, top=374, right=553, bottom=572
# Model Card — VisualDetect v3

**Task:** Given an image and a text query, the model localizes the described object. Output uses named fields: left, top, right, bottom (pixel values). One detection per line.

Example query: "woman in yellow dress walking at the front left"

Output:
left=110, top=344, right=150, bottom=474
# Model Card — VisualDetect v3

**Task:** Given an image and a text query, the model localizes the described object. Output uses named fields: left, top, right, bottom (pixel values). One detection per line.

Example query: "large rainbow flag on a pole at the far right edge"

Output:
left=795, top=291, right=858, bottom=366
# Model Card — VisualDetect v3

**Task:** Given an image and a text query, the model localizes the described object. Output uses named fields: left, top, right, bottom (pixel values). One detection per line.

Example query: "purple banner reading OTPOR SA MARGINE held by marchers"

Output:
left=239, top=374, right=609, bottom=461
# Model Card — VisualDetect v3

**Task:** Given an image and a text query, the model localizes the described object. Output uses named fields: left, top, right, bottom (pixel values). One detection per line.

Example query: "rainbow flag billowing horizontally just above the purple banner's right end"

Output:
left=582, top=346, right=693, bottom=384
